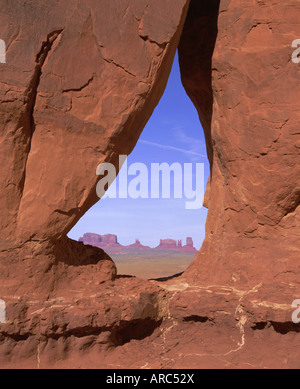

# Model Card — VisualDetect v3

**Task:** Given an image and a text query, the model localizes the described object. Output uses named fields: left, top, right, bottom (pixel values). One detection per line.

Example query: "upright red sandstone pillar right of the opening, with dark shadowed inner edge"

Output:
left=179, top=1, right=300, bottom=286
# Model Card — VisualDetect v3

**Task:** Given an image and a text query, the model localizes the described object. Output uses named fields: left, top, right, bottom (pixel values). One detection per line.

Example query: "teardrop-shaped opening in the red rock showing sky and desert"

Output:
left=68, top=49, right=209, bottom=279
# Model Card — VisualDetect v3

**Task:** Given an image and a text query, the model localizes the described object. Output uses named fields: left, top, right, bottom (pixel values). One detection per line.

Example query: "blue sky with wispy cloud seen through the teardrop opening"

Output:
left=68, top=54, right=209, bottom=249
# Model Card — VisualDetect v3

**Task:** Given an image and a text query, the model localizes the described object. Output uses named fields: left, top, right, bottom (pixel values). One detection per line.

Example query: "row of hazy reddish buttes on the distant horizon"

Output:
left=79, top=233, right=197, bottom=254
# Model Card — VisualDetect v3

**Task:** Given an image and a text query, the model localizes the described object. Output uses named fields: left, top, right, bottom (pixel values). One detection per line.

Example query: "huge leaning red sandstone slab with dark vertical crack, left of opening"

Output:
left=0, top=0, right=187, bottom=242
